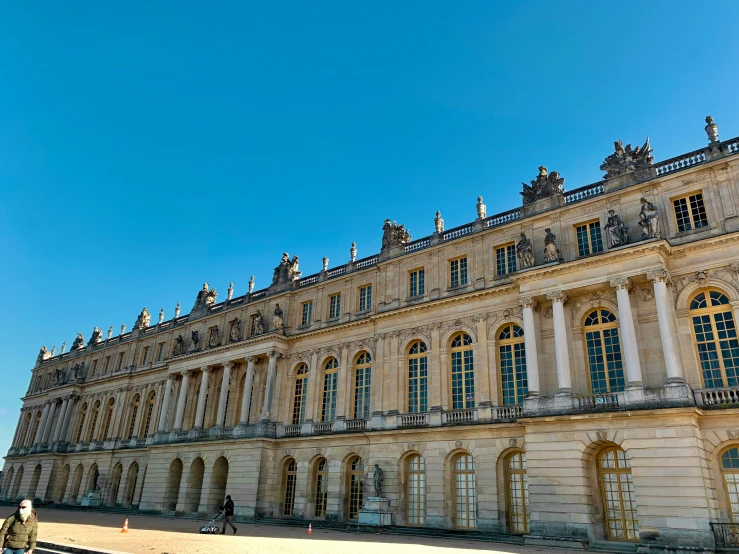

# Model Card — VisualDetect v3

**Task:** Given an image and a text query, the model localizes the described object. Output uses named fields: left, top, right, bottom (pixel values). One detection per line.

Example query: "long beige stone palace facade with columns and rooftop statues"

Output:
left=0, top=118, right=739, bottom=550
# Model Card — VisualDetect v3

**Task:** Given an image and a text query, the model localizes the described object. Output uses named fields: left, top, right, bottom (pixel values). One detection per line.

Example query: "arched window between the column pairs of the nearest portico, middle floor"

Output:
left=583, top=308, right=625, bottom=394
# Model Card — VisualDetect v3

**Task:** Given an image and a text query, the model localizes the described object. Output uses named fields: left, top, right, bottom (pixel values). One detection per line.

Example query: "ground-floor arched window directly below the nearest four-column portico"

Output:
left=598, top=446, right=639, bottom=541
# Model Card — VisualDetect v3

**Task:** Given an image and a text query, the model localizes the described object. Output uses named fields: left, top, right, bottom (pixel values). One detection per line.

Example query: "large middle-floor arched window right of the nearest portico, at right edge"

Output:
left=690, top=289, right=739, bottom=389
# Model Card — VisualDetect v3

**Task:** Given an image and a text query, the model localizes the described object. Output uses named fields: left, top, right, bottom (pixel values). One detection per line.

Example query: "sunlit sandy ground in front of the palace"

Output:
left=0, top=506, right=588, bottom=554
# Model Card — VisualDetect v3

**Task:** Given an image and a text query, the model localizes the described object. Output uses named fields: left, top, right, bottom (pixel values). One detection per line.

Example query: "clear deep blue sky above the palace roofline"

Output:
left=0, top=1, right=739, bottom=454
